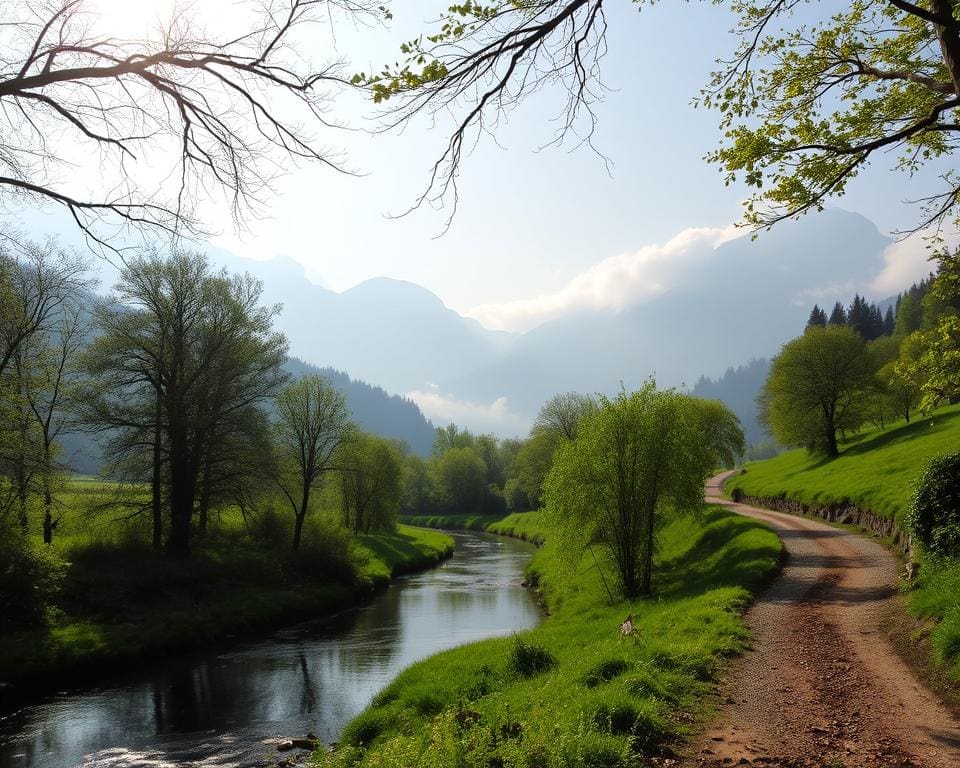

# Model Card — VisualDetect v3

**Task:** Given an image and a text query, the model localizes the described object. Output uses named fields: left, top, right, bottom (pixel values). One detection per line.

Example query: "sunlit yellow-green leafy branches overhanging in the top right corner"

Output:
left=702, top=0, right=956, bottom=225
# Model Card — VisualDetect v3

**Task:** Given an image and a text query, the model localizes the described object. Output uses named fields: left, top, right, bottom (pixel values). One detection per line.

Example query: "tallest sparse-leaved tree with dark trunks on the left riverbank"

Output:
left=85, top=251, right=286, bottom=556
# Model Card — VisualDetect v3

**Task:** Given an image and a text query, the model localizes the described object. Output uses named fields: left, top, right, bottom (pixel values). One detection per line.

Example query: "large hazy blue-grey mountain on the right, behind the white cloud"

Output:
left=441, top=211, right=890, bottom=413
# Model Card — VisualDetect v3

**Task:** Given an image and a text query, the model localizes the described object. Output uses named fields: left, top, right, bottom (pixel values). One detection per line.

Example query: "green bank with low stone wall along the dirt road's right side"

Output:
left=726, top=406, right=960, bottom=684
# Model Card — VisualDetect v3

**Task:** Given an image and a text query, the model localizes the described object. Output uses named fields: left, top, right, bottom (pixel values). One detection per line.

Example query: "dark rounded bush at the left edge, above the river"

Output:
left=0, top=530, right=67, bottom=632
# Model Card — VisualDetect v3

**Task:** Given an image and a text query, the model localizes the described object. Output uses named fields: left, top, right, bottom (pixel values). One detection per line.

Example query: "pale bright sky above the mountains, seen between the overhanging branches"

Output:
left=24, top=0, right=952, bottom=330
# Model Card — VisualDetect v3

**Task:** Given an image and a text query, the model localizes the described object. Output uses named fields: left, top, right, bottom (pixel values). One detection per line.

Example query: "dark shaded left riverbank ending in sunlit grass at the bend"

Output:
left=0, top=526, right=454, bottom=702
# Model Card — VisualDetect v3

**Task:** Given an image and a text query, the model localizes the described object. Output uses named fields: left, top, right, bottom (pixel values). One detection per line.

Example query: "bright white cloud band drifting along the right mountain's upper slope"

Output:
left=467, top=225, right=743, bottom=331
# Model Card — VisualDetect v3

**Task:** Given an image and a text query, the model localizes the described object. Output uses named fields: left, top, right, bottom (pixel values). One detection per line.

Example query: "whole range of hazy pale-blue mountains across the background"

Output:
left=201, top=210, right=906, bottom=434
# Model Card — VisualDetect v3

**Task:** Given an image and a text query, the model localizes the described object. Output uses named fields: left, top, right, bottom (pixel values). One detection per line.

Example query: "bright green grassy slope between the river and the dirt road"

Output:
left=319, top=509, right=780, bottom=768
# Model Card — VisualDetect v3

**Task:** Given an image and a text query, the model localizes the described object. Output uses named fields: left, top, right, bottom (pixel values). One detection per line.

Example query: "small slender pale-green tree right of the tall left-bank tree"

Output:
left=276, top=376, right=353, bottom=551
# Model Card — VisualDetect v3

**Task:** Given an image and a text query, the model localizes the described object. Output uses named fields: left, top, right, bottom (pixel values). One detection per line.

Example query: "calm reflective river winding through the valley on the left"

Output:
left=0, top=533, right=541, bottom=768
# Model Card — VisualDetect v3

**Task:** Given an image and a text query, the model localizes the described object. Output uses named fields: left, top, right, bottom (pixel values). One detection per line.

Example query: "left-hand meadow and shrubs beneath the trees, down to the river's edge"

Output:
left=0, top=477, right=453, bottom=687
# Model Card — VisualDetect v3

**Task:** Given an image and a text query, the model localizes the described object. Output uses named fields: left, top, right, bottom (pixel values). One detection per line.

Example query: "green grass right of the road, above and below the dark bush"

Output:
left=727, top=406, right=960, bottom=681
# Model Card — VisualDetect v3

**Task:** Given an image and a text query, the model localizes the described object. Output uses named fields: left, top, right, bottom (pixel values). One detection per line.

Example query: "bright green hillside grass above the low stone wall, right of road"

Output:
left=727, top=405, right=960, bottom=520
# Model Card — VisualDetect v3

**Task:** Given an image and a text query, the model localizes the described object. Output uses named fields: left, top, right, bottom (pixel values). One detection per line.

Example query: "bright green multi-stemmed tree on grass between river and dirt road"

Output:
left=546, top=388, right=743, bottom=597
